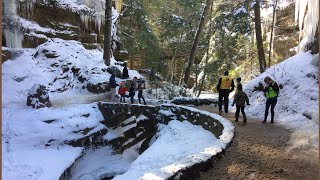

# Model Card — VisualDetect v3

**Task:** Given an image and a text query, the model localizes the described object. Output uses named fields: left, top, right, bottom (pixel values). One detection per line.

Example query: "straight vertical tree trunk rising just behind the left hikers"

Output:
left=103, top=0, right=112, bottom=66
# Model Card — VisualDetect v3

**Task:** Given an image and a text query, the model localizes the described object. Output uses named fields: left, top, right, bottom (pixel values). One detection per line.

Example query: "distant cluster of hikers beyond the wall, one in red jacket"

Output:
left=109, top=65, right=147, bottom=105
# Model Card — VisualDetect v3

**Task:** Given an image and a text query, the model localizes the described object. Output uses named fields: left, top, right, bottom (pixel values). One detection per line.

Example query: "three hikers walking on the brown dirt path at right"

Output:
left=217, top=71, right=279, bottom=123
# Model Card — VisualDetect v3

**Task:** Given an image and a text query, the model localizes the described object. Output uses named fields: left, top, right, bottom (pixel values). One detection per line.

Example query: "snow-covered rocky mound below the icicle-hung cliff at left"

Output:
left=2, top=39, right=110, bottom=105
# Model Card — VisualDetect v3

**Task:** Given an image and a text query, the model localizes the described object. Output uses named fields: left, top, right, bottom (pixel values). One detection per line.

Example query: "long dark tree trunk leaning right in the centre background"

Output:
left=184, top=0, right=213, bottom=84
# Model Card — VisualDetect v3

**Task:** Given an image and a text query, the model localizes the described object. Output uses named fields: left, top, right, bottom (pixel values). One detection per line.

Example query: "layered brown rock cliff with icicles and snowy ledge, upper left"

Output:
left=3, top=0, right=103, bottom=48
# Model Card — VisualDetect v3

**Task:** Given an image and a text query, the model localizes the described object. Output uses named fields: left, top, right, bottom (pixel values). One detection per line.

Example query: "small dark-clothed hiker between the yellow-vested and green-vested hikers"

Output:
left=232, top=84, right=250, bottom=123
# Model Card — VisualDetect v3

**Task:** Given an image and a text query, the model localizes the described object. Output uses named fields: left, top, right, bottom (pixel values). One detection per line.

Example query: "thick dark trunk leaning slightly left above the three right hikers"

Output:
left=254, top=0, right=266, bottom=73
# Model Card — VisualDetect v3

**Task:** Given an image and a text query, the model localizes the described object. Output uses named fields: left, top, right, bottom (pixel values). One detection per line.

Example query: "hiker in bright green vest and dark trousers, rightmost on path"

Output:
left=262, top=76, right=279, bottom=123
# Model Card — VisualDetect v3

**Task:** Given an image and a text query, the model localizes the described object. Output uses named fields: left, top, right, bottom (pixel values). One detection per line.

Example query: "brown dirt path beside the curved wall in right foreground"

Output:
left=197, top=106, right=319, bottom=180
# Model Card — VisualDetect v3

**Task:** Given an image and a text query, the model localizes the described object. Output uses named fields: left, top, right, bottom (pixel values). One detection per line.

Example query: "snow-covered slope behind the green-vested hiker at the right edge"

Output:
left=244, top=52, right=319, bottom=150
